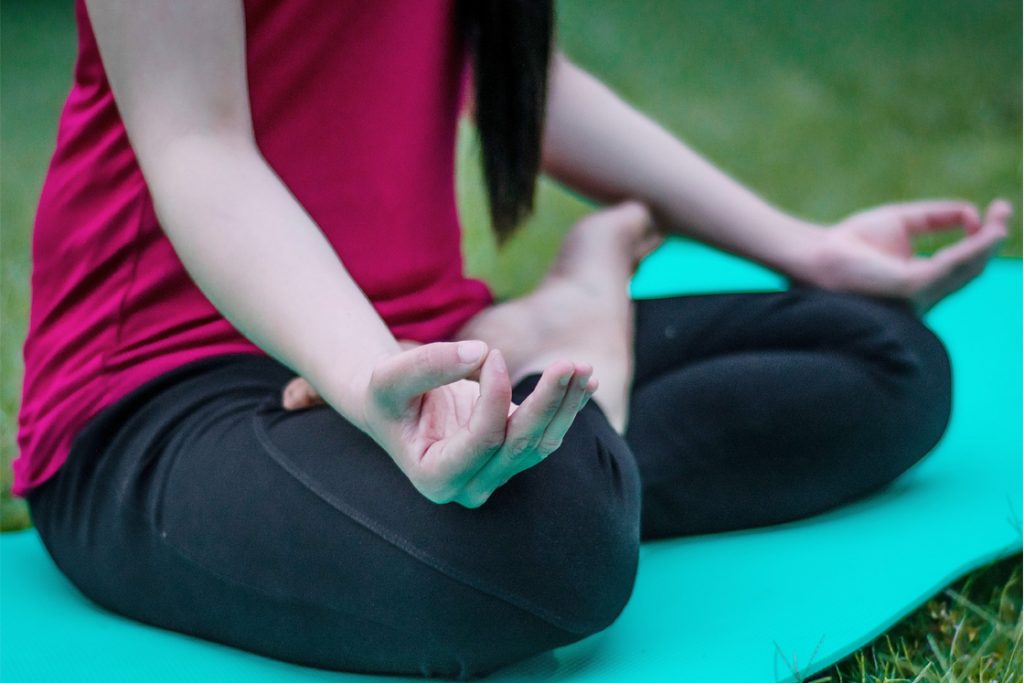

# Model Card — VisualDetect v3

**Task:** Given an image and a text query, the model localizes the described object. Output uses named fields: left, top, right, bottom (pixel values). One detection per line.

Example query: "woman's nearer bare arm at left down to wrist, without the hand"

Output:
left=87, top=0, right=399, bottom=426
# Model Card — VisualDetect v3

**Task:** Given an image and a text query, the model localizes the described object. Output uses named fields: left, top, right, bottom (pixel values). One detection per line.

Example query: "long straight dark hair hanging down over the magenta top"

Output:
left=459, top=0, right=554, bottom=245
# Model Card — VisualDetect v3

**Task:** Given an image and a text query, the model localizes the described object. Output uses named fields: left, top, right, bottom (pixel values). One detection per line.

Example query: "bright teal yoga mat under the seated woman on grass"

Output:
left=0, top=241, right=1021, bottom=683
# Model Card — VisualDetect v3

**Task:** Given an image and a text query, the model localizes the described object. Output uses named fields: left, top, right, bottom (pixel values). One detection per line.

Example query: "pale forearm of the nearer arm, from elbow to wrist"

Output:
left=146, top=136, right=399, bottom=424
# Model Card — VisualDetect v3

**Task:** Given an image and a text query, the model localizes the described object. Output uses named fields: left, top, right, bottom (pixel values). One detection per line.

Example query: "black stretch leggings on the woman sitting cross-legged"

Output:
left=29, top=287, right=950, bottom=677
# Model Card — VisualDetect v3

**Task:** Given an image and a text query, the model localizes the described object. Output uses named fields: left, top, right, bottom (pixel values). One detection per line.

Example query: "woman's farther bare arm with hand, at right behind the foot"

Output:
left=542, top=53, right=1010, bottom=311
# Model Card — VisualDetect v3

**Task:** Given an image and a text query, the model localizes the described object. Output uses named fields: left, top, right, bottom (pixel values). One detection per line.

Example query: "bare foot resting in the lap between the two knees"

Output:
left=455, top=202, right=663, bottom=433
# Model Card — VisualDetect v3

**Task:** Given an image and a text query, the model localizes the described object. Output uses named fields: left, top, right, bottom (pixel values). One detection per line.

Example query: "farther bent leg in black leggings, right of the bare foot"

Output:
left=626, top=287, right=951, bottom=539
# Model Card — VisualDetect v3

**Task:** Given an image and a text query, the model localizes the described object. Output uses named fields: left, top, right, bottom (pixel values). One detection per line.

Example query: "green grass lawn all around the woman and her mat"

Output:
left=0, top=0, right=1021, bottom=683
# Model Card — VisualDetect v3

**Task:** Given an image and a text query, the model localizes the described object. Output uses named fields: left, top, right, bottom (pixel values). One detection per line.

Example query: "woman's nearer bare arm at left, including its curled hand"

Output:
left=86, top=0, right=596, bottom=507
